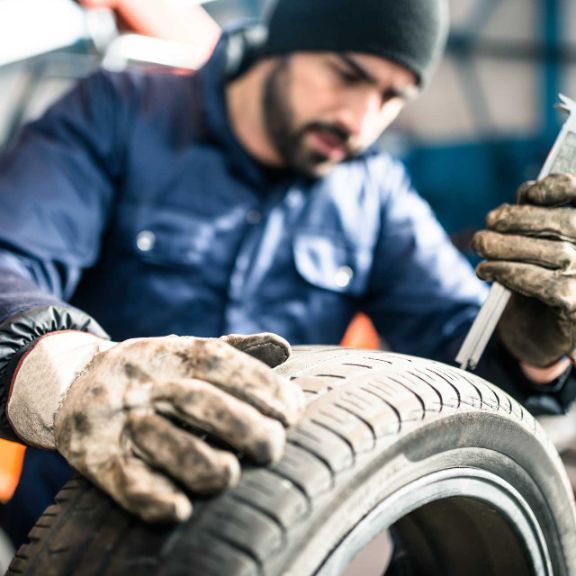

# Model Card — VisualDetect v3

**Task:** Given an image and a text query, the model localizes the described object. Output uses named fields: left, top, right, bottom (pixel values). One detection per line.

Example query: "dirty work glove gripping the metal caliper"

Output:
left=473, top=174, right=576, bottom=367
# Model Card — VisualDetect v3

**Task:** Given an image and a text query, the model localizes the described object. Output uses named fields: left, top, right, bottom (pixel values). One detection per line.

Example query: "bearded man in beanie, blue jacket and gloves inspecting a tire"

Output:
left=0, top=0, right=576, bottom=536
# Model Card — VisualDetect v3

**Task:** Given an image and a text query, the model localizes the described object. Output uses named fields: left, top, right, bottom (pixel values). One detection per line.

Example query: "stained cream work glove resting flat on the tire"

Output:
left=8, top=332, right=303, bottom=521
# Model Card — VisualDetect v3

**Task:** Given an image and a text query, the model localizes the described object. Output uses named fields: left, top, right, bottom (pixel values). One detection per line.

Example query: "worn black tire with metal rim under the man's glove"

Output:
left=7, top=348, right=576, bottom=576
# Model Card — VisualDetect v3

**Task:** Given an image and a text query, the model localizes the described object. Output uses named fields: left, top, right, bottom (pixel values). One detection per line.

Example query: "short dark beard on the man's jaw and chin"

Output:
left=263, top=57, right=360, bottom=178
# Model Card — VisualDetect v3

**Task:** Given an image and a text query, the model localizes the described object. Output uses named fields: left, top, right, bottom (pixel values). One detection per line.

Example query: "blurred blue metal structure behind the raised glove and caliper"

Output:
left=405, top=0, right=573, bottom=259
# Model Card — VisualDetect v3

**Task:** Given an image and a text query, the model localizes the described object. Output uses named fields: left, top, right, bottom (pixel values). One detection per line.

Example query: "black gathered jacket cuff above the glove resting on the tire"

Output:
left=0, top=306, right=108, bottom=442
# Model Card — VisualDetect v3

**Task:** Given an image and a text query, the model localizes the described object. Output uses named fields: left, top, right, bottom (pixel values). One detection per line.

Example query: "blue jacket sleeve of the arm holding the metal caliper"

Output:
left=364, top=157, right=488, bottom=362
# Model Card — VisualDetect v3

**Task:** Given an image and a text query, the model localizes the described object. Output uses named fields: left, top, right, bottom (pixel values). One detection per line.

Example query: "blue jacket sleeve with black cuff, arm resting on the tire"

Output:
left=0, top=72, right=131, bottom=438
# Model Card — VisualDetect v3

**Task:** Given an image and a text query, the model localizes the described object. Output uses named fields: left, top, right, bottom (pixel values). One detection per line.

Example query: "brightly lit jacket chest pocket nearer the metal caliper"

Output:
left=294, top=232, right=372, bottom=297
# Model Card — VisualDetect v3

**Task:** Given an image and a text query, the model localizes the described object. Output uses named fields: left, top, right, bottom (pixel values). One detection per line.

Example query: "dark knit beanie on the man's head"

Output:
left=264, top=0, right=448, bottom=85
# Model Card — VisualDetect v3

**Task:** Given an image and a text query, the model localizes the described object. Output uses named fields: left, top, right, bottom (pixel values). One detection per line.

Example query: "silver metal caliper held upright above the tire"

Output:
left=456, top=94, right=576, bottom=370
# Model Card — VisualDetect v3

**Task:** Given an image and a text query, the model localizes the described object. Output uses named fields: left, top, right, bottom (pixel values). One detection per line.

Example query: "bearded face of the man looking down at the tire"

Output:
left=263, top=52, right=418, bottom=176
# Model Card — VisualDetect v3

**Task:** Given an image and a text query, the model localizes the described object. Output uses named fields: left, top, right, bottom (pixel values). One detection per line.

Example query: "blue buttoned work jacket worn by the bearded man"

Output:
left=0, top=23, right=504, bottom=436
